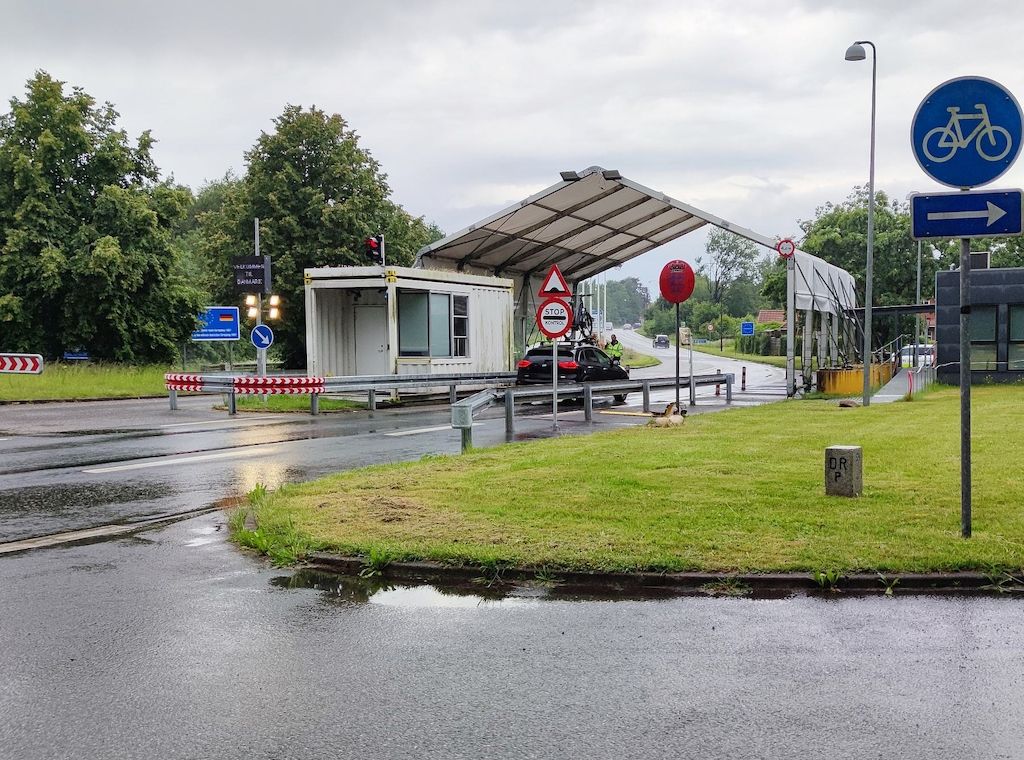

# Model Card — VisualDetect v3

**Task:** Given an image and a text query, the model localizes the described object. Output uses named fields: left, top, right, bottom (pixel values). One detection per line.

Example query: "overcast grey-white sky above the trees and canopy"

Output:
left=6, top=0, right=1024, bottom=294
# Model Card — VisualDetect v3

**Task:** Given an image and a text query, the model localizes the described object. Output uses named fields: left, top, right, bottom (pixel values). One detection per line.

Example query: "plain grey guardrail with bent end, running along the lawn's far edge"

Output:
left=452, top=372, right=736, bottom=452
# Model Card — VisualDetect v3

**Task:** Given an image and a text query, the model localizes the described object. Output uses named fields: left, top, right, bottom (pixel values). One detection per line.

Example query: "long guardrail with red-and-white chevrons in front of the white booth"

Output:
left=171, top=372, right=516, bottom=415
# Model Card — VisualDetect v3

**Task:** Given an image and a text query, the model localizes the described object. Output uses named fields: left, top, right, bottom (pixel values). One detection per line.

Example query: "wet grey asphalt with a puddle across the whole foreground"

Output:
left=0, top=515, right=1024, bottom=760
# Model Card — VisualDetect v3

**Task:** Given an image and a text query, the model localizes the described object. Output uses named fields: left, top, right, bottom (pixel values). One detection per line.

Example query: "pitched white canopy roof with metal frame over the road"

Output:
left=414, top=166, right=775, bottom=283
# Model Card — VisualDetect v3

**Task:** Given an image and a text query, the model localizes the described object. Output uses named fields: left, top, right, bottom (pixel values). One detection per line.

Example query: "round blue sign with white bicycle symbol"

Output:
left=910, top=77, right=1024, bottom=187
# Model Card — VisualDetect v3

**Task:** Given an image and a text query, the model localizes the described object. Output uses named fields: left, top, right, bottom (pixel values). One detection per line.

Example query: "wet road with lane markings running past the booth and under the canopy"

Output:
left=0, top=342, right=784, bottom=542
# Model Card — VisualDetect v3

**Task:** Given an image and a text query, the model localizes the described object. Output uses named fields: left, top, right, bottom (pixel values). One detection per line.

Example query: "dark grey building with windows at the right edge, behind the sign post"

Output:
left=935, top=267, right=1024, bottom=385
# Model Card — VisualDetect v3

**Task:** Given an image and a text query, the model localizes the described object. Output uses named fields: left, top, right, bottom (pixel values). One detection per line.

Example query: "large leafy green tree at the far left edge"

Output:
left=0, top=72, right=202, bottom=362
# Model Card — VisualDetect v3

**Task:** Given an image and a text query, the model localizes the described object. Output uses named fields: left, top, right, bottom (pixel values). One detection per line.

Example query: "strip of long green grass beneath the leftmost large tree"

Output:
left=0, top=364, right=173, bottom=402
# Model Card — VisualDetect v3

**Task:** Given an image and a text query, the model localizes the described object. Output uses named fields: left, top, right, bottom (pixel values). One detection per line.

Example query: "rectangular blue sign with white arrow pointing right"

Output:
left=910, top=189, right=1024, bottom=240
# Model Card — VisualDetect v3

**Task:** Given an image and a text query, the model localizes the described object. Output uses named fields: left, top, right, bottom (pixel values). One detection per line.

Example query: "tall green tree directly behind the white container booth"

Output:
left=200, top=105, right=442, bottom=367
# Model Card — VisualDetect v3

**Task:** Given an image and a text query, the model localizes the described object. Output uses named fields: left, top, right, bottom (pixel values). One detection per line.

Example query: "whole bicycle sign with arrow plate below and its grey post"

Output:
left=910, top=77, right=1024, bottom=539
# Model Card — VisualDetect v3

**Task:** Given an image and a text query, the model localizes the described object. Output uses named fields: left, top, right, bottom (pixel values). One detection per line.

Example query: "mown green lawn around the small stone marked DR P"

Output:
left=234, top=386, right=1024, bottom=573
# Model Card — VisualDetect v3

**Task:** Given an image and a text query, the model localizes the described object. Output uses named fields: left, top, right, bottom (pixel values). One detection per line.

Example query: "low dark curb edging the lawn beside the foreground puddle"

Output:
left=306, top=552, right=1016, bottom=594
